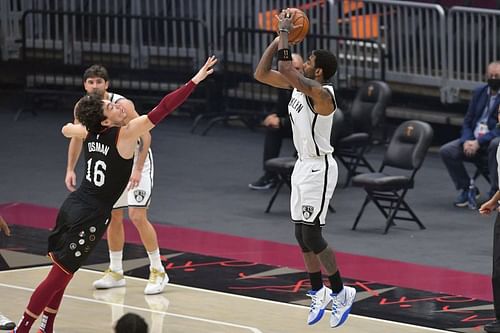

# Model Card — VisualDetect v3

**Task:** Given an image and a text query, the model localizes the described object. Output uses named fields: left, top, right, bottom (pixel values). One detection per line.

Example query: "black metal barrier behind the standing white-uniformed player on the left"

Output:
left=21, top=10, right=208, bottom=95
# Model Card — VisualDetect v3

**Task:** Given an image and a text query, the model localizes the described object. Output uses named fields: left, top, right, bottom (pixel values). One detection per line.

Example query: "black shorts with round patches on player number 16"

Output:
left=48, top=192, right=111, bottom=273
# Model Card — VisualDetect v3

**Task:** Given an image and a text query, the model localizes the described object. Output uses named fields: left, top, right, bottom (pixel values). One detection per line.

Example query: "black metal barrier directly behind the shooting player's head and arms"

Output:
left=192, top=27, right=385, bottom=135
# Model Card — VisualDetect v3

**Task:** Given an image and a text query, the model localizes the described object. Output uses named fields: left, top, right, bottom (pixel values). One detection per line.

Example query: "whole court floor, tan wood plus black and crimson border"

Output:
left=0, top=203, right=494, bottom=333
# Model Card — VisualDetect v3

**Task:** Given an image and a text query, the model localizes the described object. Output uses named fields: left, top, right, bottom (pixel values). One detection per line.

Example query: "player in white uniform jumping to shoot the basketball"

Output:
left=255, top=9, right=356, bottom=327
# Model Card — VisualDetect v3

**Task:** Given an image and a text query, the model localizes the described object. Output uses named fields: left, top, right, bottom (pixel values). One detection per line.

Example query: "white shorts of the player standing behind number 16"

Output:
left=113, top=149, right=154, bottom=209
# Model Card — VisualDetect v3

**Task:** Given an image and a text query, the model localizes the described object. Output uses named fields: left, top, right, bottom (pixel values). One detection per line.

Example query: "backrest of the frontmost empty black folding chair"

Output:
left=382, top=120, right=434, bottom=170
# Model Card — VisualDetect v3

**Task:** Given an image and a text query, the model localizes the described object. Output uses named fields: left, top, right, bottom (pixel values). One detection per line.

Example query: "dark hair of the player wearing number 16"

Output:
left=75, top=93, right=106, bottom=133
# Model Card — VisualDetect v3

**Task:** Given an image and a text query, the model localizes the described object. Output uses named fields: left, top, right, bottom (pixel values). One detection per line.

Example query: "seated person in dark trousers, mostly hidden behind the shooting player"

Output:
left=248, top=53, right=304, bottom=190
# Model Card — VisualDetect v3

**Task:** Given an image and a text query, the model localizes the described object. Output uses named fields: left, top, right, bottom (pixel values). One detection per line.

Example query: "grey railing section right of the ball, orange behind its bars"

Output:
left=332, top=0, right=447, bottom=87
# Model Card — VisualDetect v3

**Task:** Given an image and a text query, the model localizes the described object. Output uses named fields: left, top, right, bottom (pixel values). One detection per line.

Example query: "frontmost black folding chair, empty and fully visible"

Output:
left=352, top=120, right=433, bottom=234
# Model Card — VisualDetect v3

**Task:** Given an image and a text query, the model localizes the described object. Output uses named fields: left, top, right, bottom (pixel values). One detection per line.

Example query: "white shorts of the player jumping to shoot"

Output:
left=290, top=154, right=338, bottom=226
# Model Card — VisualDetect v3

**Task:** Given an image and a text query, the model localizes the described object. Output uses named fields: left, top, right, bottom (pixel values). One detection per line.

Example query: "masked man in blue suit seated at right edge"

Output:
left=439, top=61, right=500, bottom=207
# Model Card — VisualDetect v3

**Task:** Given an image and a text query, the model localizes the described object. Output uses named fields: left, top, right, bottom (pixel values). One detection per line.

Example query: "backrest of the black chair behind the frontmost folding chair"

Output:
left=350, top=81, right=392, bottom=133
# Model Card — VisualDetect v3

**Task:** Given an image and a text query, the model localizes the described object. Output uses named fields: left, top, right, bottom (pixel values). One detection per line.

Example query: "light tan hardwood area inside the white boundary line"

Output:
left=0, top=266, right=452, bottom=333
